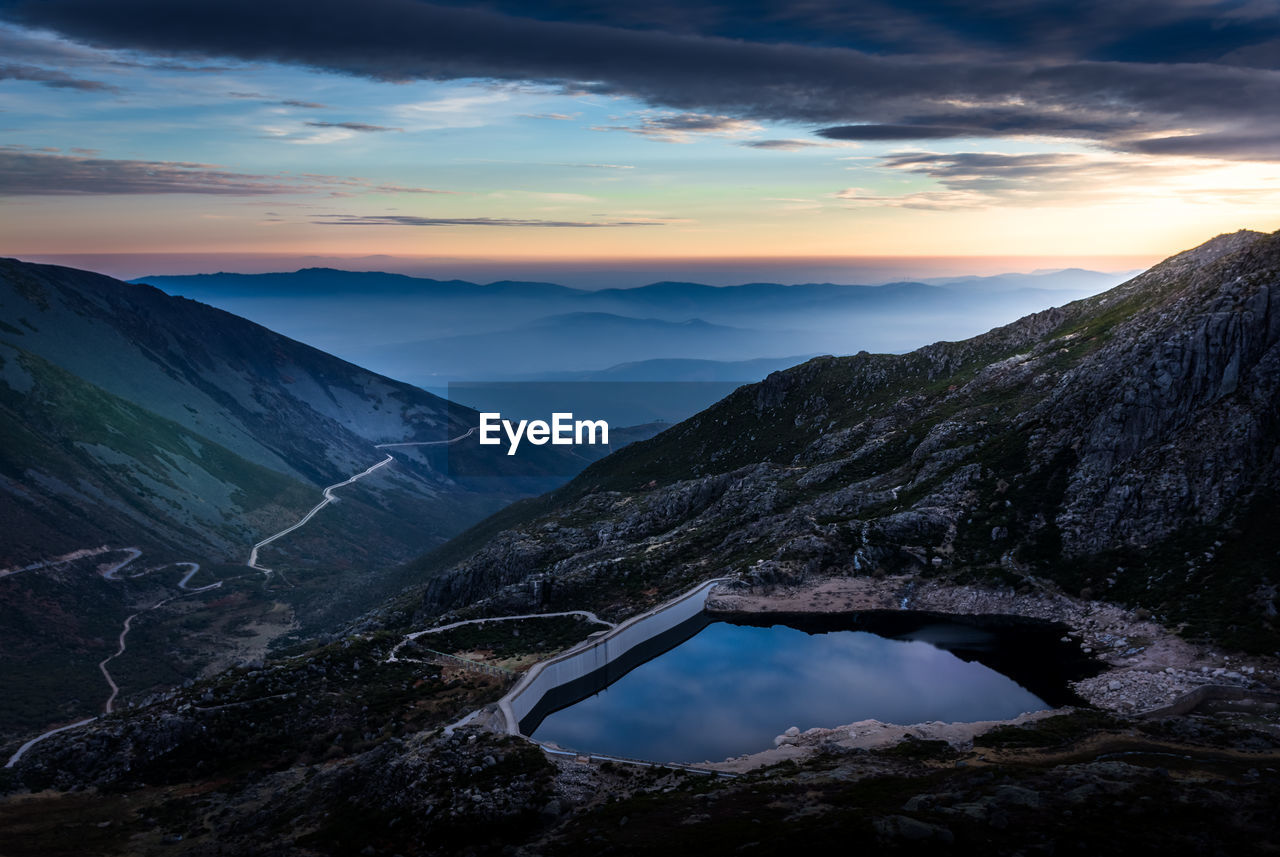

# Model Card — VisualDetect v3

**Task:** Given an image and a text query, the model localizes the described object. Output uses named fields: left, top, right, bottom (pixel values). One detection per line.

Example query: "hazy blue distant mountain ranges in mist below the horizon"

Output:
left=137, top=269, right=1123, bottom=389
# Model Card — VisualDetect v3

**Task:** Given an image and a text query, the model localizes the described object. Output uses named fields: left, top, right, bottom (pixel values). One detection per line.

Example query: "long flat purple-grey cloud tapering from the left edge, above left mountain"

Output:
left=0, top=146, right=451, bottom=196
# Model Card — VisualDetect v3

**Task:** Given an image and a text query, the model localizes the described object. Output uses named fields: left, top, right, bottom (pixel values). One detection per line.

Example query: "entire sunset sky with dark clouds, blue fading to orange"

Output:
left=0, top=0, right=1280, bottom=281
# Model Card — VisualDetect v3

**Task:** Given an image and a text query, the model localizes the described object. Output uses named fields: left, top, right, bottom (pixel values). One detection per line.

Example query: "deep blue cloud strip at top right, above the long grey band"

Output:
left=366, top=0, right=1280, bottom=68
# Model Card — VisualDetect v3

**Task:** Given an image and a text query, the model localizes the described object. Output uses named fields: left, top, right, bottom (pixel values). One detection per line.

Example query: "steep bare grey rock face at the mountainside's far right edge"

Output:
left=1034, top=237, right=1280, bottom=554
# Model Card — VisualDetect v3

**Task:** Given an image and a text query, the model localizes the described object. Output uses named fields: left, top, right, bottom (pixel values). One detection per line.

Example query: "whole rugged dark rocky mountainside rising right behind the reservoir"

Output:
left=404, top=227, right=1280, bottom=651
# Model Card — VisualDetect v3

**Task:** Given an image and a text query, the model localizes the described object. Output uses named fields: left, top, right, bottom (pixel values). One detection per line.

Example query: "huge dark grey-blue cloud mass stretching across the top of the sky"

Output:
left=0, top=0, right=1280, bottom=159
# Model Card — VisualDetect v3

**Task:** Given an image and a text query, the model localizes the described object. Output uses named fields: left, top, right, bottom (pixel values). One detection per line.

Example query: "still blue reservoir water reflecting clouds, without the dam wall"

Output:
left=521, top=614, right=1080, bottom=762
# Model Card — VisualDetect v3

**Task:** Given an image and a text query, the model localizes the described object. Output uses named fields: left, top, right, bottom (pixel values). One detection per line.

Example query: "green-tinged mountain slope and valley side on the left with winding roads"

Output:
left=0, top=260, right=585, bottom=735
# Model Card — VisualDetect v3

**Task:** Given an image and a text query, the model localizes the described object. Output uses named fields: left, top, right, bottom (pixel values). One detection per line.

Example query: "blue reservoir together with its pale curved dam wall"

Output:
left=499, top=581, right=1093, bottom=764
